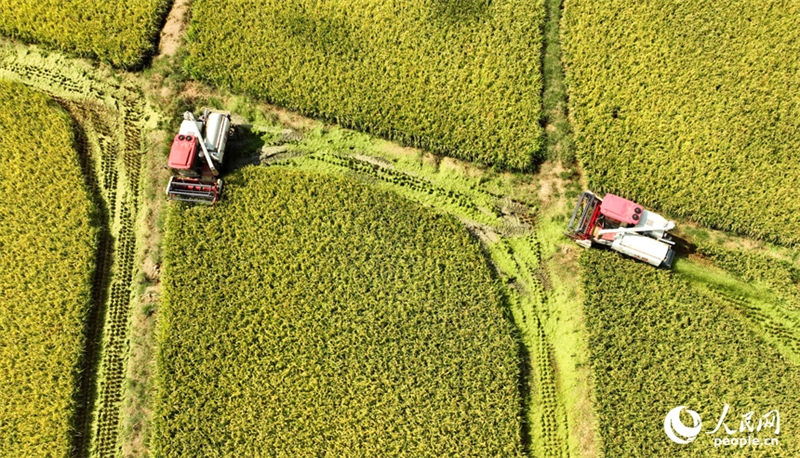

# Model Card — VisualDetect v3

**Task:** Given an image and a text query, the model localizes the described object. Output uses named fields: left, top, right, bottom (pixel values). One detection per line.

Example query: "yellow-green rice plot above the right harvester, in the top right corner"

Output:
left=562, top=0, right=800, bottom=245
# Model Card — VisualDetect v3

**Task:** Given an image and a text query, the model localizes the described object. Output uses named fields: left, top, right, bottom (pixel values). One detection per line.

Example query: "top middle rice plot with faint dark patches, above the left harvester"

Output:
left=183, top=0, right=544, bottom=169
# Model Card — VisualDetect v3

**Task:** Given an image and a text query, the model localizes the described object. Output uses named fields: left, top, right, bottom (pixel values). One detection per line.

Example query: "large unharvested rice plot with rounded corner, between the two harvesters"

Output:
left=154, top=168, right=522, bottom=457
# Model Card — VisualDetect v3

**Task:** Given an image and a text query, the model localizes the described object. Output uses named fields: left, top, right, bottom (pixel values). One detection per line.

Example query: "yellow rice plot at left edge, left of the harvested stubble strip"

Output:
left=0, top=80, right=96, bottom=457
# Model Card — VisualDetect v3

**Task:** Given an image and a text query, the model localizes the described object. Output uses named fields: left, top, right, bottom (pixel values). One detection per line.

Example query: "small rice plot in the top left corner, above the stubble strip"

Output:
left=0, top=0, right=171, bottom=68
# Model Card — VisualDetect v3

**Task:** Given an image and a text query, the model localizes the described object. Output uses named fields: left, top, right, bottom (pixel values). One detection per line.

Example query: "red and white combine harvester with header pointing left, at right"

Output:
left=565, top=191, right=675, bottom=269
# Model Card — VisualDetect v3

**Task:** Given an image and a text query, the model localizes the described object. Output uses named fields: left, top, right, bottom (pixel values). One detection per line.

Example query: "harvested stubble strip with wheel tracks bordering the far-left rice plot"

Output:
left=0, top=46, right=144, bottom=457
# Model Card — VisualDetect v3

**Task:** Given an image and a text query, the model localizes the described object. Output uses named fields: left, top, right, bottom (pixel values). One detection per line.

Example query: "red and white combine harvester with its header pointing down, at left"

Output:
left=167, top=110, right=231, bottom=205
